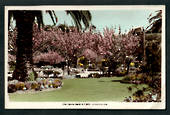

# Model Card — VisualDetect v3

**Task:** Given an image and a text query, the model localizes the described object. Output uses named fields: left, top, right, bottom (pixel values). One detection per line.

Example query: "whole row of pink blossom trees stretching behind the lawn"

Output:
left=9, top=24, right=140, bottom=74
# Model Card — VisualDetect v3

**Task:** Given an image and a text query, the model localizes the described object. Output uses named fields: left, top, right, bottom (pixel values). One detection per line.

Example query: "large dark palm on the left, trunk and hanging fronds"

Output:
left=8, top=10, right=91, bottom=81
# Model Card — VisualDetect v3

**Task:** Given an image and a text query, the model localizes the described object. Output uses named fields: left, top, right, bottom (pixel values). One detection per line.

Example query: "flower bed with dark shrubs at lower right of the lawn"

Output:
left=122, top=74, right=161, bottom=102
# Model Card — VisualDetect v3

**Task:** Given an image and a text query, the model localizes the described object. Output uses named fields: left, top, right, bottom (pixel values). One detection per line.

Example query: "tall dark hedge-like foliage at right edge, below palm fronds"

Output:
left=145, top=34, right=161, bottom=75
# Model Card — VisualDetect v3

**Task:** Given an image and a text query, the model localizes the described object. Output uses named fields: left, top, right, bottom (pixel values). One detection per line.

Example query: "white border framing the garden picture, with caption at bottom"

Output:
left=4, top=5, right=166, bottom=109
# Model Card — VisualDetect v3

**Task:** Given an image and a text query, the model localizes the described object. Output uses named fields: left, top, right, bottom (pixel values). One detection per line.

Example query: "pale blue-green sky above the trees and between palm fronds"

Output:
left=43, top=9, right=155, bottom=33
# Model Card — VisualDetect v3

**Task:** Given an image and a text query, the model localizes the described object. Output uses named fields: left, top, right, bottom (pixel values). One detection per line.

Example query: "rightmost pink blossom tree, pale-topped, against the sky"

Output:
left=96, top=28, right=141, bottom=73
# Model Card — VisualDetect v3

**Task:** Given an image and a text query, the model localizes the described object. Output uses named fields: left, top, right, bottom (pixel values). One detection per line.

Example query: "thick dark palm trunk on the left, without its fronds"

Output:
left=13, top=11, right=34, bottom=81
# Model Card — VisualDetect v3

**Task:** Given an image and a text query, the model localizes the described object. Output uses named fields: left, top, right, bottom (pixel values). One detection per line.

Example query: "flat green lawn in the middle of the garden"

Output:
left=9, top=77, right=146, bottom=102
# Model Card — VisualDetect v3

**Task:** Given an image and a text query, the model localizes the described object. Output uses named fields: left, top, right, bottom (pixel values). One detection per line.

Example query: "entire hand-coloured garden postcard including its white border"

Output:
left=4, top=5, right=166, bottom=109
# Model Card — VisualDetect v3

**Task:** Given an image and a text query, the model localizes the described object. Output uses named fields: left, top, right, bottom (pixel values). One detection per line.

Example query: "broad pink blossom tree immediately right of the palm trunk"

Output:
left=33, top=25, right=102, bottom=66
